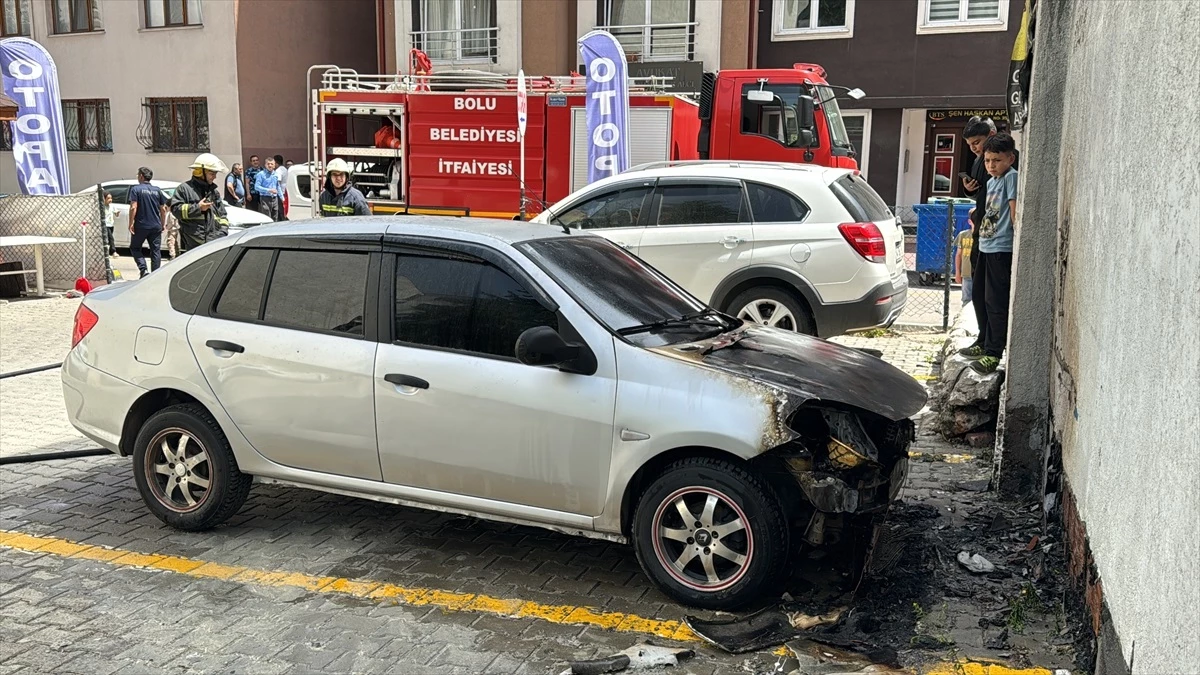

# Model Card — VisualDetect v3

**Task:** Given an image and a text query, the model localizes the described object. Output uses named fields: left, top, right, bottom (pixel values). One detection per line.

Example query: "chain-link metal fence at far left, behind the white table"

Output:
left=0, top=193, right=108, bottom=293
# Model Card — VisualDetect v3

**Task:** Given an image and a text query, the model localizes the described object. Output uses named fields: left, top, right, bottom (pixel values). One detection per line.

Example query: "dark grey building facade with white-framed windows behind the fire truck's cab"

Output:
left=754, top=0, right=1025, bottom=207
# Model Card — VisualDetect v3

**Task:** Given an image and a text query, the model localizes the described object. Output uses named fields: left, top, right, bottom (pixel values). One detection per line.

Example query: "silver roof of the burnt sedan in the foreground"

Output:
left=239, top=215, right=580, bottom=244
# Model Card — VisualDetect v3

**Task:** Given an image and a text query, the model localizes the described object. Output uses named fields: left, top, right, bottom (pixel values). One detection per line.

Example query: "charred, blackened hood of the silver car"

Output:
left=652, top=324, right=928, bottom=420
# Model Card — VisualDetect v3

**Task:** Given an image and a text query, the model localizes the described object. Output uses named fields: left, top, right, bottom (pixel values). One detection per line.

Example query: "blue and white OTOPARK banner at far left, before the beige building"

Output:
left=0, top=37, right=71, bottom=195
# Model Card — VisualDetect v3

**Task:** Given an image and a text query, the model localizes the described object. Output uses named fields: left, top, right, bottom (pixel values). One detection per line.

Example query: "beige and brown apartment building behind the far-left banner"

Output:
left=0, top=0, right=378, bottom=192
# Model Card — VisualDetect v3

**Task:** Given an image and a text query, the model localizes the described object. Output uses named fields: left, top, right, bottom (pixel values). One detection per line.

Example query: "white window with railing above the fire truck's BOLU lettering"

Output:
left=412, top=0, right=499, bottom=64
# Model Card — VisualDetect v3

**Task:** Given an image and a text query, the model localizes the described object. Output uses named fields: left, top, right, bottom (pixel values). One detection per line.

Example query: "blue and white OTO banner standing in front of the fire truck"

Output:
left=580, top=30, right=629, bottom=183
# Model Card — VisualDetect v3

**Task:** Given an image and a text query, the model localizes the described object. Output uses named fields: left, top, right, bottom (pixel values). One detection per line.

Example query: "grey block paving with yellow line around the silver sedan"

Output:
left=0, top=299, right=1060, bottom=675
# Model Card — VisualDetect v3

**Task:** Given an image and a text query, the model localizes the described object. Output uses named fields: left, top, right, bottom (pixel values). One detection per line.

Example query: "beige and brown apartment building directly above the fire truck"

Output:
left=380, top=0, right=752, bottom=91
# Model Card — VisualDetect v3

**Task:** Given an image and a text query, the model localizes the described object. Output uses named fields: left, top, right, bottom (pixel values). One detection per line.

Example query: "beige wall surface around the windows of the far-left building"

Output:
left=0, top=0, right=241, bottom=192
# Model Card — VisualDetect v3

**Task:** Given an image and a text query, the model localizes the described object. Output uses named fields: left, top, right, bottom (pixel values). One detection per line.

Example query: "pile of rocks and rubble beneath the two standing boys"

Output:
left=929, top=305, right=1004, bottom=448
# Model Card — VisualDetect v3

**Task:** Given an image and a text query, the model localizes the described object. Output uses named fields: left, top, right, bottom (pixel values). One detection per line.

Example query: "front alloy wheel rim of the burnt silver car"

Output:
left=654, top=486, right=754, bottom=592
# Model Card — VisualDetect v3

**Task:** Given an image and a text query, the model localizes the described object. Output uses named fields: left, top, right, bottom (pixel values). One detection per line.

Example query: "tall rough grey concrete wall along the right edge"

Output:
left=1009, top=0, right=1200, bottom=674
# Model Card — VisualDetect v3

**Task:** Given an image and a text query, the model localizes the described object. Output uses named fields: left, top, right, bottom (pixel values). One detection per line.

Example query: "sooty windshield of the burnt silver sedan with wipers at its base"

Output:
left=517, top=237, right=736, bottom=346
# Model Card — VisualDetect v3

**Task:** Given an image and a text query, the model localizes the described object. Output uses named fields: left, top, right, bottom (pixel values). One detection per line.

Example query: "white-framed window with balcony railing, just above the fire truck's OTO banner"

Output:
left=599, top=0, right=696, bottom=61
